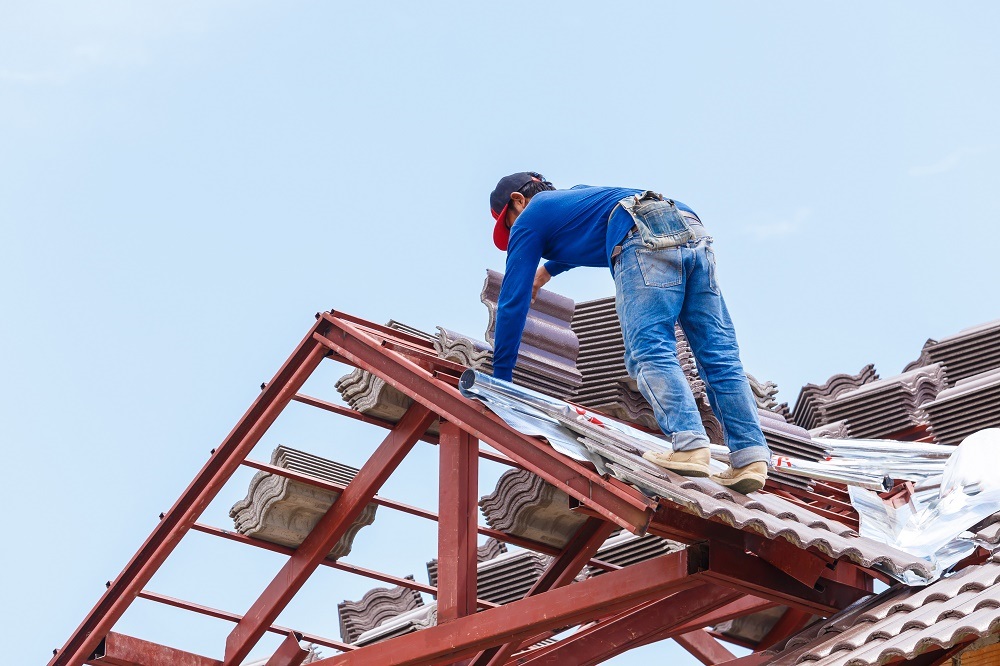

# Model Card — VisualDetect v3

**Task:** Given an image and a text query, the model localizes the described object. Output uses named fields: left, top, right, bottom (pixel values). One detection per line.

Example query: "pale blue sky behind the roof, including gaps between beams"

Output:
left=0, top=0, right=1000, bottom=664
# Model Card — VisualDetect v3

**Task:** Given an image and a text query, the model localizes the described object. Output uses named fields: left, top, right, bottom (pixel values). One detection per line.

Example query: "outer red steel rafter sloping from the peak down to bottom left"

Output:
left=49, top=319, right=329, bottom=666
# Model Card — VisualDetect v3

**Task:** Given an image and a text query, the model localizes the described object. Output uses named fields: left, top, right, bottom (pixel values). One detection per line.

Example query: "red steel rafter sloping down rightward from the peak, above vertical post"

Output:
left=316, top=314, right=654, bottom=534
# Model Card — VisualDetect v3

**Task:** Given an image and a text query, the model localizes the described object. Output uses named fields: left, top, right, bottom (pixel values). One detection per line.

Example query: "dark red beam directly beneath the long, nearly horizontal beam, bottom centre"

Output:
left=508, top=584, right=739, bottom=666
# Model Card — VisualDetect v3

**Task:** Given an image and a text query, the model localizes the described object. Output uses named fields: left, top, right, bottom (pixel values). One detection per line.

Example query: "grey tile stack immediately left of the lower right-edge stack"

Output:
left=823, top=363, right=945, bottom=438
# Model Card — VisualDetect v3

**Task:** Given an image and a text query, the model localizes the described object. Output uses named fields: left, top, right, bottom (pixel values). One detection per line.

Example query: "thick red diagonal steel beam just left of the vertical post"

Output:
left=224, top=403, right=435, bottom=666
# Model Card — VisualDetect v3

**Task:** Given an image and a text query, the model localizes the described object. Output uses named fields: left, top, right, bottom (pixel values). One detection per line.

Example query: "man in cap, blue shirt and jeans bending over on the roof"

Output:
left=490, top=172, right=771, bottom=493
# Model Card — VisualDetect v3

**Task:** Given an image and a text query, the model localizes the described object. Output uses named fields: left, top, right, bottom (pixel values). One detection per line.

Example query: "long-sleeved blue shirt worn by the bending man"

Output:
left=493, top=185, right=694, bottom=381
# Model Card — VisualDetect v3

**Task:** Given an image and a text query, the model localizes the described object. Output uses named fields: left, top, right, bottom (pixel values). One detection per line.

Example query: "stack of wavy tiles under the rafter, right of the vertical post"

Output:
left=479, top=469, right=587, bottom=548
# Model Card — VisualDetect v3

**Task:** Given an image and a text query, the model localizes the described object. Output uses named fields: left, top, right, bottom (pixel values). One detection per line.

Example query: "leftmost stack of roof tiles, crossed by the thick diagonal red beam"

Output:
left=229, top=446, right=378, bottom=559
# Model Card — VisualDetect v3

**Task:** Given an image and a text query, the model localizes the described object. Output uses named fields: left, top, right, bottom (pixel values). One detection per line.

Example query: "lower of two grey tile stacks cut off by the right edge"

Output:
left=923, top=368, right=1000, bottom=444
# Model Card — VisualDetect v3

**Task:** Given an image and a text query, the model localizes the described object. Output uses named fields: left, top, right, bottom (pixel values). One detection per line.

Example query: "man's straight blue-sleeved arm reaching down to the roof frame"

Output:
left=493, top=224, right=542, bottom=381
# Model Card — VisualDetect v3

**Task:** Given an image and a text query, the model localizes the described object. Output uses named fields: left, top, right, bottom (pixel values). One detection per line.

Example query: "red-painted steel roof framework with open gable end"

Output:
left=49, top=311, right=884, bottom=666
